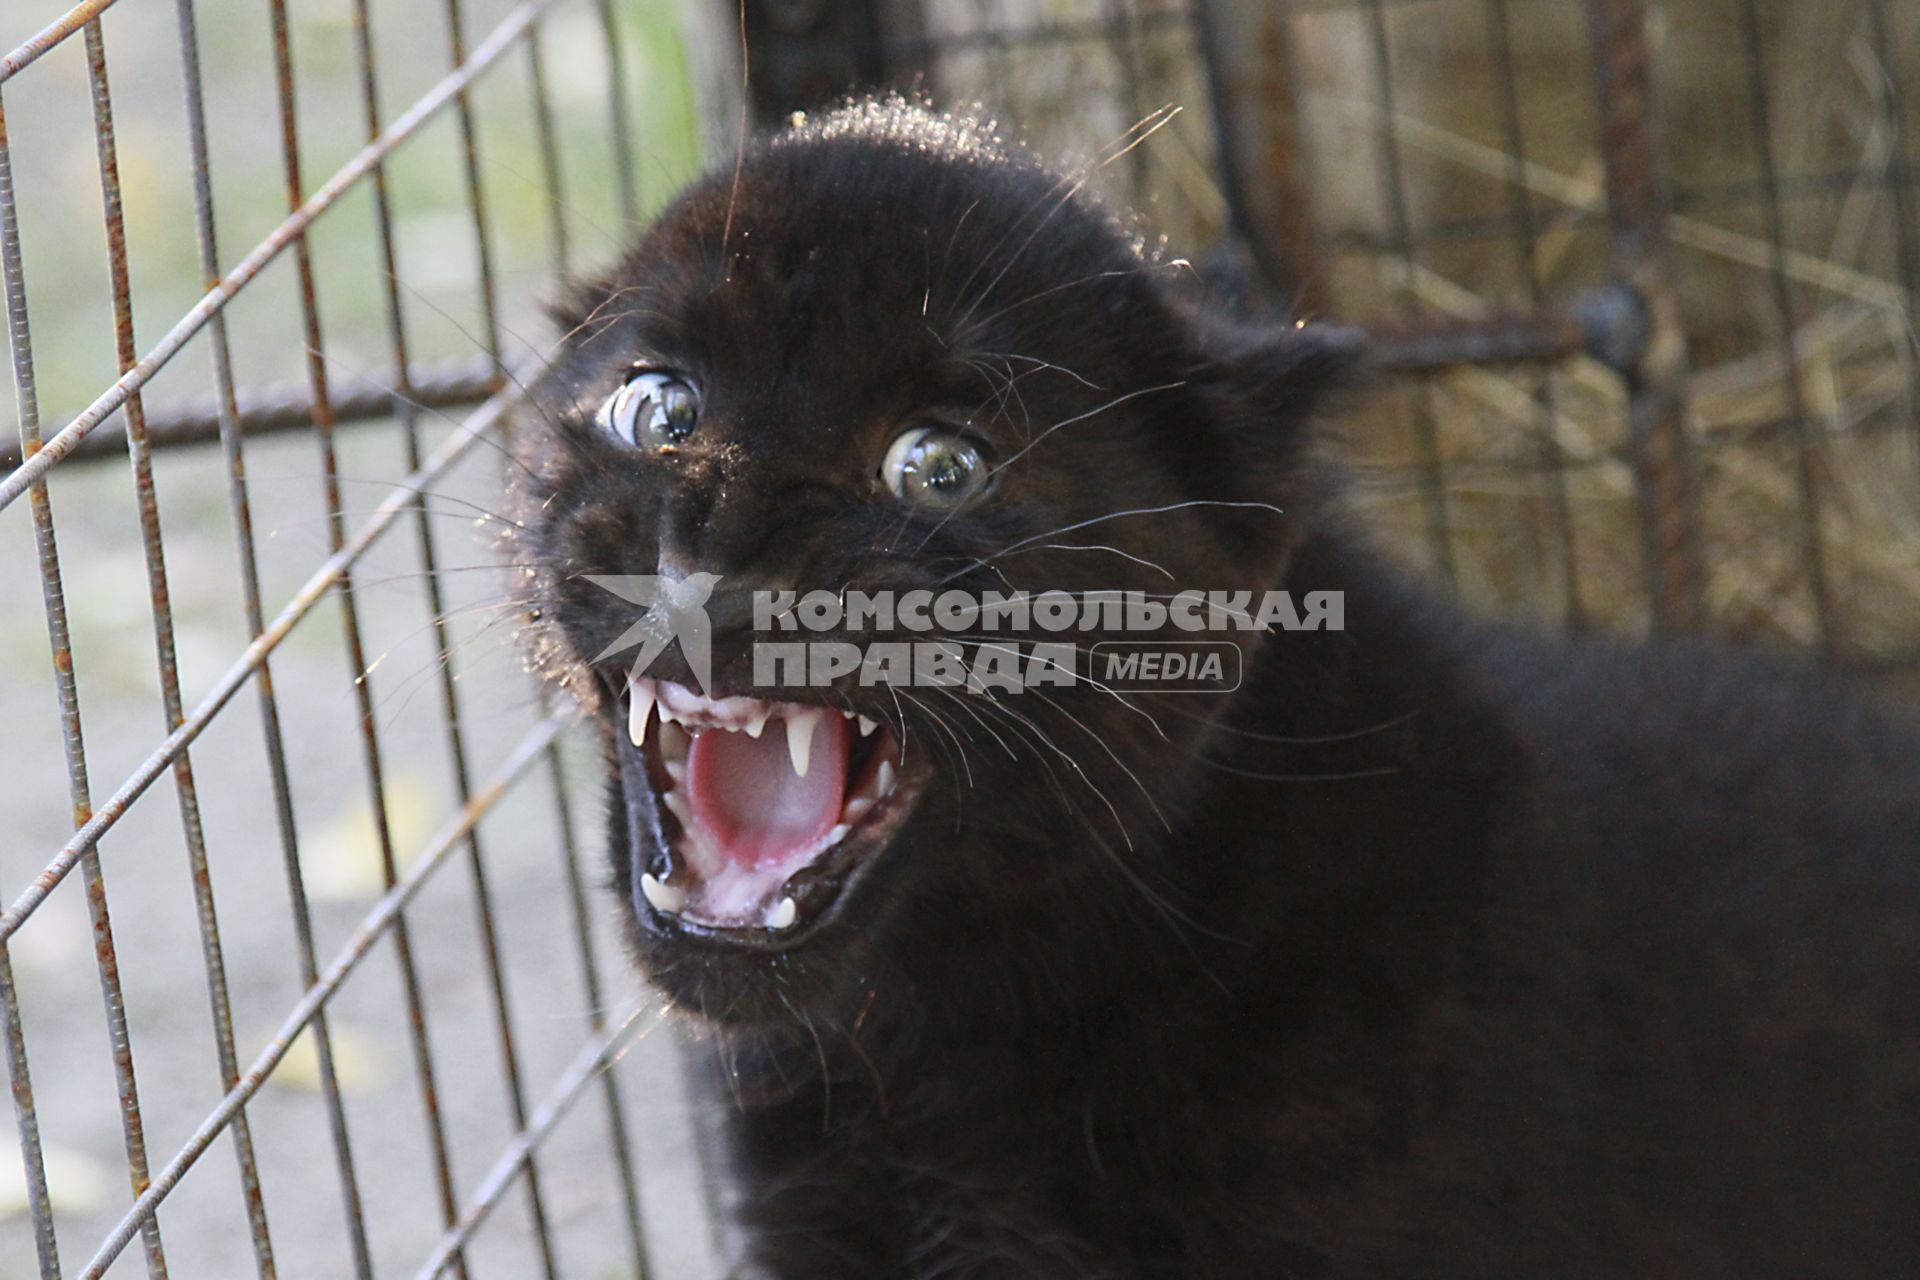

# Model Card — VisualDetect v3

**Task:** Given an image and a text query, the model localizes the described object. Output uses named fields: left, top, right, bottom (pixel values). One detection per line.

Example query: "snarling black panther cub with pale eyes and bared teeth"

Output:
left=516, top=102, right=1920, bottom=1280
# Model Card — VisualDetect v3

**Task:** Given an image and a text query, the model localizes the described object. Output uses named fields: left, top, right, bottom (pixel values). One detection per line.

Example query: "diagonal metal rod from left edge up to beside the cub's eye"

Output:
left=0, top=370, right=522, bottom=942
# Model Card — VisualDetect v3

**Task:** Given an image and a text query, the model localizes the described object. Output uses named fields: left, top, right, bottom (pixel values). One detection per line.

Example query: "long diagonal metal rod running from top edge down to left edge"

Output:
left=0, top=0, right=559, bottom=510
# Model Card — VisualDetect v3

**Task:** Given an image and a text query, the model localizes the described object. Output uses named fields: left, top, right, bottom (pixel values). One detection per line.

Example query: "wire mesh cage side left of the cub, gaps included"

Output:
left=0, top=0, right=721, bottom=1276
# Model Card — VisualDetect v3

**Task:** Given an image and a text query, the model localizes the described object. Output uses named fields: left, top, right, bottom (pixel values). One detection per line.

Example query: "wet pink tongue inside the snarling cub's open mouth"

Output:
left=687, top=714, right=851, bottom=867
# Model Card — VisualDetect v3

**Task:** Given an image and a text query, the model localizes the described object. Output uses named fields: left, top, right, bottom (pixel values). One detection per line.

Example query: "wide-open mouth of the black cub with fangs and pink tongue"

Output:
left=618, top=677, right=918, bottom=940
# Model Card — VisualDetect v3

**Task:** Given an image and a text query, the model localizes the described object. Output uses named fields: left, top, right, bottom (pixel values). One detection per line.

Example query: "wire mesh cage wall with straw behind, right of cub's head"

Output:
left=867, top=0, right=1920, bottom=674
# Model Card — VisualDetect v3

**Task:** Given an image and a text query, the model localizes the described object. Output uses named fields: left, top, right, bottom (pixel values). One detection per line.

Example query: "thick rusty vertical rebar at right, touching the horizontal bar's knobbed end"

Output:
left=1586, top=0, right=1701, bottom=631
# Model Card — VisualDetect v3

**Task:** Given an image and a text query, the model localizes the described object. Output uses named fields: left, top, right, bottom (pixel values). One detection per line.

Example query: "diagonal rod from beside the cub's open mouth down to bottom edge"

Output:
left=81, top=720, right=563, bottom=1280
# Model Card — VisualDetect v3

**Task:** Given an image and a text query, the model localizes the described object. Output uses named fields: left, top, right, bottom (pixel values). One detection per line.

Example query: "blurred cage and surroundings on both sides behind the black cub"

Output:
left=0, top=0, right=1920, bottom=1280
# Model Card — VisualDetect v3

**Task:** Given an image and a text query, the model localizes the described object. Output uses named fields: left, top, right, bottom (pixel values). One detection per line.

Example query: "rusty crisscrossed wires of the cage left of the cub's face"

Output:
left=0, top=0, right=668, bottom=1280
